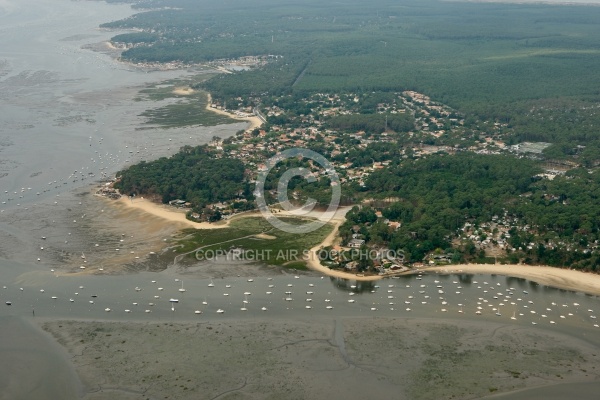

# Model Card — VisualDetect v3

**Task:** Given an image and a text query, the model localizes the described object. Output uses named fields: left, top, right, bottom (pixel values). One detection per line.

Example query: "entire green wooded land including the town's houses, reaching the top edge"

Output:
left=103, top=0, right=600, bottom=271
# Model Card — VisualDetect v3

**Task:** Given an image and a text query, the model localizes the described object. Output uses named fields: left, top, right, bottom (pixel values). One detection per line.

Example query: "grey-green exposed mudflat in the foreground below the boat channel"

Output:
left=43, top=318, right=600, bottom=400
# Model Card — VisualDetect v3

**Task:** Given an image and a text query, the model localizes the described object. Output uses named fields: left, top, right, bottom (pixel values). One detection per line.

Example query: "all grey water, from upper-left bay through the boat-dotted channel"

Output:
left=0, top=0, right=600, bottom=400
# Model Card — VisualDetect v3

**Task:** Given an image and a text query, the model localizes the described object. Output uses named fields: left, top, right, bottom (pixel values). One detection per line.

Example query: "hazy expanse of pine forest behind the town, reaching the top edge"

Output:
left=104, top=0, right=600, bottom=158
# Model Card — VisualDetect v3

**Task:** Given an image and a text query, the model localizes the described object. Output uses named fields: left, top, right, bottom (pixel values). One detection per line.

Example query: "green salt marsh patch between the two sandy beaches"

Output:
left=177, top=216, right=333, bottom=269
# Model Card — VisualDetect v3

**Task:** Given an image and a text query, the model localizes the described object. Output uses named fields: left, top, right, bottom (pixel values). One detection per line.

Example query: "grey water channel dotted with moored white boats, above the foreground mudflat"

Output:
left=0, top=262, right=600, bottom=344
